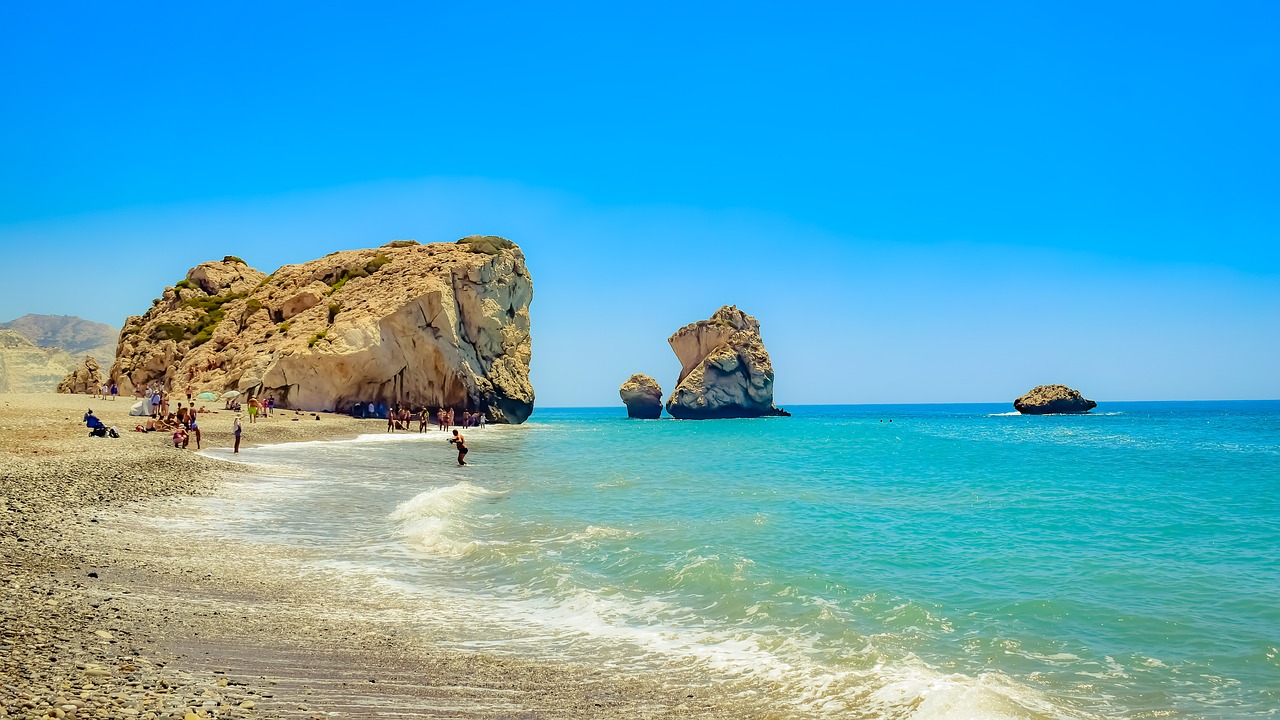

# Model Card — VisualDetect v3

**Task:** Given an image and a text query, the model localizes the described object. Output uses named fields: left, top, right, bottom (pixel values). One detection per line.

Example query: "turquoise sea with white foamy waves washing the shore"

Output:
left=172, top=401, right=1280, bottom=719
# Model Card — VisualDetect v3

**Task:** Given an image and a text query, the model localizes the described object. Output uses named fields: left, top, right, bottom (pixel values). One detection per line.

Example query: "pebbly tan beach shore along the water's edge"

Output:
left=0, top=395, right=768, bottom=720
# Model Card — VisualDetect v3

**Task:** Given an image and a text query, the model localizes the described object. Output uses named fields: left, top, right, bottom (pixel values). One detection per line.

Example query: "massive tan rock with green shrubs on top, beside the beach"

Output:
left=111, top=236, right=534, bottom=423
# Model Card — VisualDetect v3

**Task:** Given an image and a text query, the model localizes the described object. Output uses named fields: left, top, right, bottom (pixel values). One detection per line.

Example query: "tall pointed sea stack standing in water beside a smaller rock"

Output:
left=667, top=305, right=787, bottom=420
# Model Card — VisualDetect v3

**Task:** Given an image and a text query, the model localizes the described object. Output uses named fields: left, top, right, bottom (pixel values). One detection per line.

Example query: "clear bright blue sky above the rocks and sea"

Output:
left=0, top=0, right=1280, bottom=406
